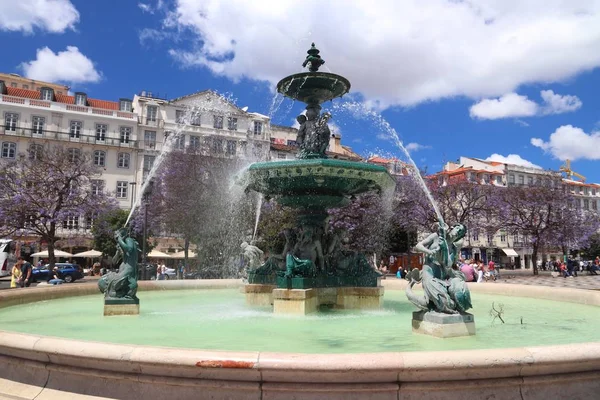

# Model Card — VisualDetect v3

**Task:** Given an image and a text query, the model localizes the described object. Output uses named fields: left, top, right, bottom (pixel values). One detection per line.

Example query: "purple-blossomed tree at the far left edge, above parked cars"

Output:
left=0, top=145, right=117, bottom=266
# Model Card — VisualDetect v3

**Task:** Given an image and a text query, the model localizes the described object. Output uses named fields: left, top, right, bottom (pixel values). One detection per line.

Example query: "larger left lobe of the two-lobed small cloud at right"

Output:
left=469, top=93, right=538, bottom=119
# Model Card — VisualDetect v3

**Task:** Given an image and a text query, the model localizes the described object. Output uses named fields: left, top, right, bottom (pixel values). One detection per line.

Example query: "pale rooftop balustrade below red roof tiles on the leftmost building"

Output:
left=0, top=125, right=138, bottom=148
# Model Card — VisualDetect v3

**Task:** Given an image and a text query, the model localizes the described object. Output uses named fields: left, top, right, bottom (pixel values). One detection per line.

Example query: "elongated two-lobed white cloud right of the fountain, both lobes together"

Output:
left=469, top=90, right=583, bottom=119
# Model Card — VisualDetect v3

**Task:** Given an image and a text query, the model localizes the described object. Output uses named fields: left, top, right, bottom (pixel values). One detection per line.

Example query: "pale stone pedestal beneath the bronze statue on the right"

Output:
left=412, top=311, right=475, bottom=338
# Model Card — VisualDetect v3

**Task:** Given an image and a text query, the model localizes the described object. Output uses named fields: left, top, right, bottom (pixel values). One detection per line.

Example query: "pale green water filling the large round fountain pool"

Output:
left=0, top=289, right=600, bottom=353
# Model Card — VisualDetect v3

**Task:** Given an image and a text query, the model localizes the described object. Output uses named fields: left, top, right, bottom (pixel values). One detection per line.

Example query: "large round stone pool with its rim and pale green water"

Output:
left=0, top=279, right=600, bottom=400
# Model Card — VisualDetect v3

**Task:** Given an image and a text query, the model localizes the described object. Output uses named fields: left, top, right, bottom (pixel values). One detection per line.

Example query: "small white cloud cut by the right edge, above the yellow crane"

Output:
left=531, top=125, right=600, bottom=160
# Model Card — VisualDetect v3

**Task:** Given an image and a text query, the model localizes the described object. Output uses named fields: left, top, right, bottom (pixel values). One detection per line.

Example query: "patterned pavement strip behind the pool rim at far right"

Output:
left=481, top=270, right=600, bottom=290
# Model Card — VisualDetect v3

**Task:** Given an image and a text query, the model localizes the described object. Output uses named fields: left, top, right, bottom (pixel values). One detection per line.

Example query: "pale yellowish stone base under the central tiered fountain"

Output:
left=243, top=284, right=384, bottom=315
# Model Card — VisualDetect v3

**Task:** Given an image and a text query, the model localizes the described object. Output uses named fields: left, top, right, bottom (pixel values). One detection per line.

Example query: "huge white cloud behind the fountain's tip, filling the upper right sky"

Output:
left=151, top=0, right=600, bottom=107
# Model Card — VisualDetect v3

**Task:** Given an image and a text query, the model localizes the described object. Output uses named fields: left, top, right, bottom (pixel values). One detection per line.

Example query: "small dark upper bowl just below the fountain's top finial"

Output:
left=277, top=72, right=350, bottom=104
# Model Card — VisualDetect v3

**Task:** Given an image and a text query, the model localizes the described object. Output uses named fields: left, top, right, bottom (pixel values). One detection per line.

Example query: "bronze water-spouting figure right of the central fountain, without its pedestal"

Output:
left=406, top=222, right=472, bottom=314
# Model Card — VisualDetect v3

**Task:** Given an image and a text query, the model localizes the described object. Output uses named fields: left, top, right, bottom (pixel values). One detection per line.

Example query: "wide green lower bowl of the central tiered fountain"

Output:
left=239, top=159, right=395, bottom=207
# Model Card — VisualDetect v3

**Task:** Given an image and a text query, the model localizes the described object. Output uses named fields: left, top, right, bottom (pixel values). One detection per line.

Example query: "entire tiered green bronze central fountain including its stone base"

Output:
left=240, top=43, right=395, bottom=313
